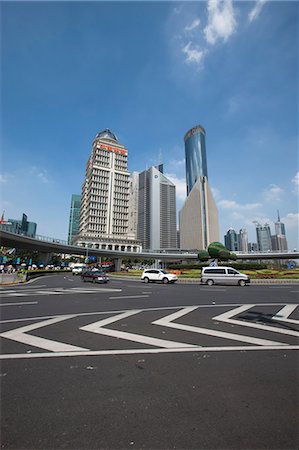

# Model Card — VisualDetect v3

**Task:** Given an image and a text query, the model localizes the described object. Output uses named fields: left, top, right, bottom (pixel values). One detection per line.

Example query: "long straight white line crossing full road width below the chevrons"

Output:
left=0, top=345, right=299, bottom=360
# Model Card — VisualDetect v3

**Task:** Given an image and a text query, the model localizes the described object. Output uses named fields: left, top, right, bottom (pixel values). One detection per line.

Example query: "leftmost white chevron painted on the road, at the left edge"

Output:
left=0, top=315, right=88, bottom=352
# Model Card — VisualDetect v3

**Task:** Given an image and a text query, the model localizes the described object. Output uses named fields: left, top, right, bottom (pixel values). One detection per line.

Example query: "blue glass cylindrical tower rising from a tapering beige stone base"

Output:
left=180, top=125, right=219, bottom=250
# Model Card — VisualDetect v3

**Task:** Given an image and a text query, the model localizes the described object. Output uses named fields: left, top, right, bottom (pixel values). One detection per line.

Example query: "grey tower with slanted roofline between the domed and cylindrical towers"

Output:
left=138, top=164, right=177, bottom=250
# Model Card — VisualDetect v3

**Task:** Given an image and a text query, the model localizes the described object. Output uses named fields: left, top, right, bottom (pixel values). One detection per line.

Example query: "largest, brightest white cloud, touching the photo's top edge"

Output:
left=204, top=0, right=237, bottom=45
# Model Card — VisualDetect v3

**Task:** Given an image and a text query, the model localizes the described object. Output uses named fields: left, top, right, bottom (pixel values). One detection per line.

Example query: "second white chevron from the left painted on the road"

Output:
left=79, top=309, right=198, bottom=348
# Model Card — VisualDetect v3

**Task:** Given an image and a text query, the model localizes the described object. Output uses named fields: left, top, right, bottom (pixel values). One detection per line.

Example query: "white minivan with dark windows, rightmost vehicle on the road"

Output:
left=200, top=266, right=250, bottom=286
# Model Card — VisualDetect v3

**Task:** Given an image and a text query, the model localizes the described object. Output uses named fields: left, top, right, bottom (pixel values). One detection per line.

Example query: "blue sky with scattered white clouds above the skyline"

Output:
left=0, top=0, right=299, bottom=249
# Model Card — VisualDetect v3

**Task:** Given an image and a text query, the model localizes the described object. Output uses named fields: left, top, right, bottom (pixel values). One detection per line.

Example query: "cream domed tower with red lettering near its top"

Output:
left=76, top=128, right=141, bottom=251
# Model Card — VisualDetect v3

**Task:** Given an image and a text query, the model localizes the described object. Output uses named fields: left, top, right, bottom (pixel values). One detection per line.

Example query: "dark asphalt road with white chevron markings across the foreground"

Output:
left=0, top=274, right=299, bottom=450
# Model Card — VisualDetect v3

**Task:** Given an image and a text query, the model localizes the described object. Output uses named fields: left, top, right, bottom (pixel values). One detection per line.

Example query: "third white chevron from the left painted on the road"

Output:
left=153, top=305, right=287, bottom=345
